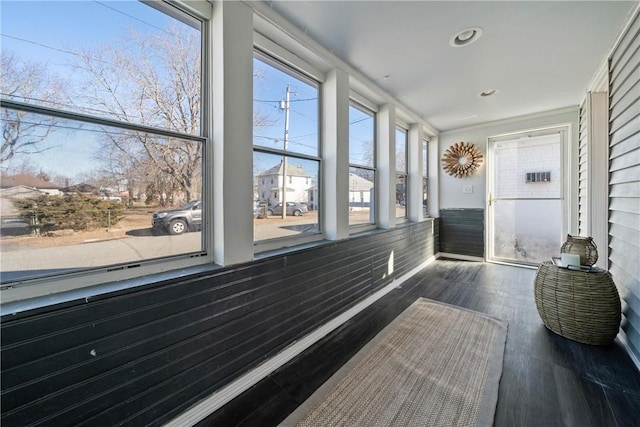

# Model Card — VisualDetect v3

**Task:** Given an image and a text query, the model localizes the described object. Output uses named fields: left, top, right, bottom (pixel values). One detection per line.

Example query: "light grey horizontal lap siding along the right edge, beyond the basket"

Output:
left=609, top=12, right=640, bottom=359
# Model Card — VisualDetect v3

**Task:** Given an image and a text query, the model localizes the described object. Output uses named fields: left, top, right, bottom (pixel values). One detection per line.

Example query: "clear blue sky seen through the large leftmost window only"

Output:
left=0, top=0, right=186, bottom=182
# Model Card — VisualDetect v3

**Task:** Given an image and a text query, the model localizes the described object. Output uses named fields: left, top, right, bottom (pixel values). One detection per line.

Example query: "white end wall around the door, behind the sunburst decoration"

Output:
left=438, top=106, right=578, bottom=212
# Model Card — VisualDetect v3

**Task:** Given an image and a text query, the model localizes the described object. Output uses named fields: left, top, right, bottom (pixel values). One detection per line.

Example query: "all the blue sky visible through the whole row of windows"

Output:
left=0, top=0, right=373, bottom=183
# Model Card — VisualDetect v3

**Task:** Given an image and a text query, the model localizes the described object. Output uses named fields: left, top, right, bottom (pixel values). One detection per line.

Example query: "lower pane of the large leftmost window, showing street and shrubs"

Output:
left=0, top=108, right=204, bottom=282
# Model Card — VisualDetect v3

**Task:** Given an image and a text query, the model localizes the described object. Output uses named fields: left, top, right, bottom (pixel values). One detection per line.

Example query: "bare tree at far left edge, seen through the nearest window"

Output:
left=0, top=51, right=61, bottom=163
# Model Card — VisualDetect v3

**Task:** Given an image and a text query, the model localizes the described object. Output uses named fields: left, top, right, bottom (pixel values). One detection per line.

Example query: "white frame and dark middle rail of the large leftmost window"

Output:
left=0, top=1, right=219, bottom=308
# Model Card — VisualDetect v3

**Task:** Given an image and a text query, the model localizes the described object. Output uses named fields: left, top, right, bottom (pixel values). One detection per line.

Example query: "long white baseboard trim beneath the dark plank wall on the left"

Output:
left=165, top=256, right=436, bottom=427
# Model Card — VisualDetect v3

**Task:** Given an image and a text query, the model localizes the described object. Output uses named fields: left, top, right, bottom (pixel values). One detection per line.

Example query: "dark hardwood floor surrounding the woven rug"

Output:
left=201, top=260, right=640, bottom=427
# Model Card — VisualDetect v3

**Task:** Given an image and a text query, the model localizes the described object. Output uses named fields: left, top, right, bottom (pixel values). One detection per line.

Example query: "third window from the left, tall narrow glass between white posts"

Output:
left=349, top=102, right=376, bottom=225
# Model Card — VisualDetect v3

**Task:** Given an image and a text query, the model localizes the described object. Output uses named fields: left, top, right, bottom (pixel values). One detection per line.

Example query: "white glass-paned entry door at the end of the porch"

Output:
left=487, top=128, right=567, bottom=265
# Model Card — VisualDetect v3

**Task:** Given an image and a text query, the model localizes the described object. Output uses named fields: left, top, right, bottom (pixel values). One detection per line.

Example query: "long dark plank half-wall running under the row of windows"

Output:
left=1, top=221, right=434, bottom=426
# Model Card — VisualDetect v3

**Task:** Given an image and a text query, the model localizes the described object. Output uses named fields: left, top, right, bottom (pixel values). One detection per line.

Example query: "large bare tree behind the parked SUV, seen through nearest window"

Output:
left=73, top=25, right=203, bottom=204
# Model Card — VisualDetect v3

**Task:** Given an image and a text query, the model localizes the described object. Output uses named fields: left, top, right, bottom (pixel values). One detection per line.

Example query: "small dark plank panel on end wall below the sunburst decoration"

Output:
left=440, top=209, right=484, bottom=258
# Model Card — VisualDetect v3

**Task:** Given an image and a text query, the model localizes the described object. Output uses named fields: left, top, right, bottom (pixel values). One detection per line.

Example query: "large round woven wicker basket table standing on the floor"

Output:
left=534, top=262, right=621, bottom=345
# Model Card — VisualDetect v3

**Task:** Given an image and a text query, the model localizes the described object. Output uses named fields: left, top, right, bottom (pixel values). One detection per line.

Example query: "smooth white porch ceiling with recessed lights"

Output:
left=267, top=0, right=637, bottom=131
